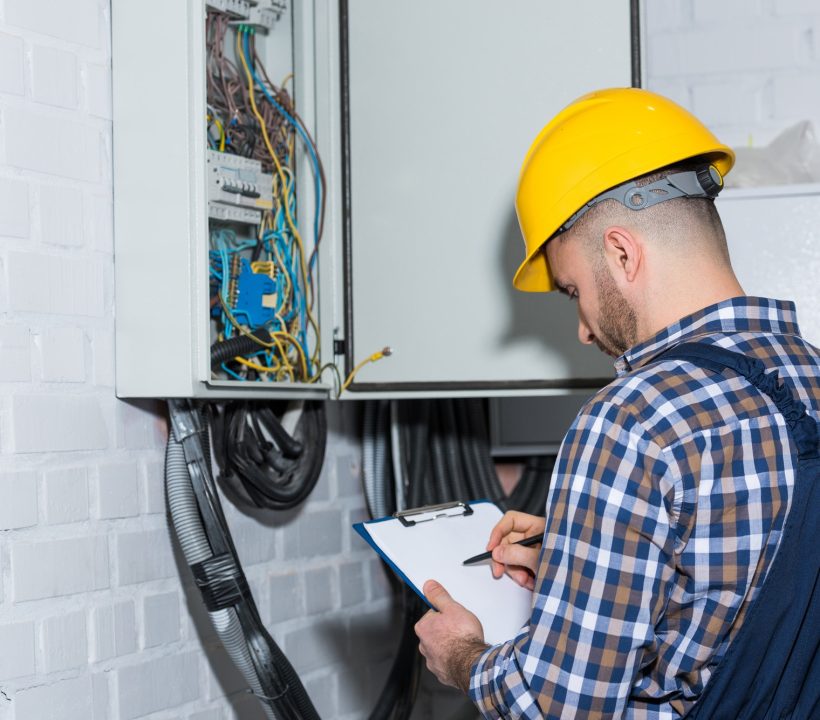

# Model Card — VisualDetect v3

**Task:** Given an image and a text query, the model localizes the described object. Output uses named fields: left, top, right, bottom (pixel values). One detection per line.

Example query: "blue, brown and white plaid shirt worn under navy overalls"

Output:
left=470, top=297, right=820, bottom=718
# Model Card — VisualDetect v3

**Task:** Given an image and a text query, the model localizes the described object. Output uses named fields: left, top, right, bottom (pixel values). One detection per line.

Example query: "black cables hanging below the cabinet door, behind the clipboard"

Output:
left=363, top=400, right=555, bottom=720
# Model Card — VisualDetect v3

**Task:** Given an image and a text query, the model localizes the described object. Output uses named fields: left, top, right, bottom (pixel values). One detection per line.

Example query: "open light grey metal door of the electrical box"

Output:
left=342, top=0, right=630, bottom=394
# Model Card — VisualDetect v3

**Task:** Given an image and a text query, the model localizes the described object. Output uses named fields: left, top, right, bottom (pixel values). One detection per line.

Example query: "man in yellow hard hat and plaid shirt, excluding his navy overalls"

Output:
left=417, top=89, right=820, bottom=718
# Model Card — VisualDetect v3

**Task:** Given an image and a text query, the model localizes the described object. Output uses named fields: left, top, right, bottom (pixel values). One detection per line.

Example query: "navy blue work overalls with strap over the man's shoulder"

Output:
left=655, top=343, right=820, bottom=720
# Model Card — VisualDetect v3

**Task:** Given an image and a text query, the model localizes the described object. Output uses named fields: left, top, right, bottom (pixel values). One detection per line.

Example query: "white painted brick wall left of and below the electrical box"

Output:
left=0, top=0, right=454, bottom=720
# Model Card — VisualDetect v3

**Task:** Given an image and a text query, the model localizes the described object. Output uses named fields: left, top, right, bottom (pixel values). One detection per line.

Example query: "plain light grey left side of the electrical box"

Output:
left=112, top=0, right=196, bottom=397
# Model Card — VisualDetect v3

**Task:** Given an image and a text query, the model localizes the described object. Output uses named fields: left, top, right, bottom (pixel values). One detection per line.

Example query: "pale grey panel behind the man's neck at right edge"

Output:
left=717, top=185, right=820, bottom=345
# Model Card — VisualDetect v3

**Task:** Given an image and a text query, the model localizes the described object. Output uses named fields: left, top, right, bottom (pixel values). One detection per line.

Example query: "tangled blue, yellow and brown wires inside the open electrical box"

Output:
left=206, top=11, right=326, bottom=382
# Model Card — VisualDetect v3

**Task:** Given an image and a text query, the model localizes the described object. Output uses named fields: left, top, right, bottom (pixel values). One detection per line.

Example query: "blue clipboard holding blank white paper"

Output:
left=353, top=500, right=532, bottom=645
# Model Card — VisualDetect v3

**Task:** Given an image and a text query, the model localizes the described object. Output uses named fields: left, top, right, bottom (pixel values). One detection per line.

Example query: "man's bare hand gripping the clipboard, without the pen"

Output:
left=416, top=580, right=488, bottom=692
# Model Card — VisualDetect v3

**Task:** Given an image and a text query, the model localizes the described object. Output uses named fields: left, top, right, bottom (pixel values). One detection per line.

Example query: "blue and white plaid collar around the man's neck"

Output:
left=615, top=296, right=800, bottom=376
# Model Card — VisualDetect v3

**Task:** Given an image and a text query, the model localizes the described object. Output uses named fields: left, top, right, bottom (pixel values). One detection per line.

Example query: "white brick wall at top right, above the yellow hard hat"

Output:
left=644, top=0, right=820, bottom=147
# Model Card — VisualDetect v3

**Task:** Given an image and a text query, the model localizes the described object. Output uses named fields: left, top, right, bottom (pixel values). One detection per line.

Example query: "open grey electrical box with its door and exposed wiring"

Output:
left=112, top=0, right=632, bottom=398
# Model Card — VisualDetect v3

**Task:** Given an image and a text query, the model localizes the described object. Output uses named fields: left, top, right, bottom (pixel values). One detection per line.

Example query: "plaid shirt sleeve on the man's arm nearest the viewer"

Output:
left=469, top=399, right=680, bottom=718
